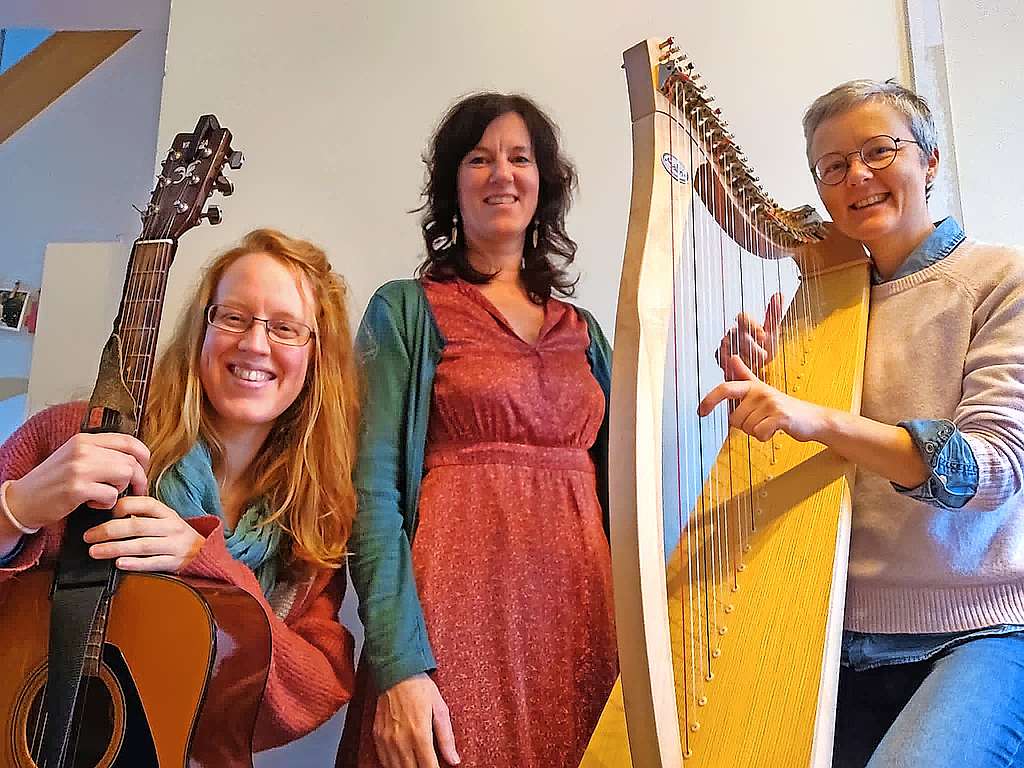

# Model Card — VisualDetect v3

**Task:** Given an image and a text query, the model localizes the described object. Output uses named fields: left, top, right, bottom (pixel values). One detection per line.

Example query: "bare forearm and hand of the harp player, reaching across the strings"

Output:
left=697, top=352, right=931, bottom=488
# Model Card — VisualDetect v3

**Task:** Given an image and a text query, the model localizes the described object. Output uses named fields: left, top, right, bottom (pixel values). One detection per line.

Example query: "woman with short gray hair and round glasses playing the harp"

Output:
left=700, top=80, right=1024, bottom=768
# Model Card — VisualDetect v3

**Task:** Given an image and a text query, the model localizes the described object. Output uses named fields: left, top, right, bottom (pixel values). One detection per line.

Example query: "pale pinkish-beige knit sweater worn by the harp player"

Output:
left=846, top=241, right=1024, bottom=633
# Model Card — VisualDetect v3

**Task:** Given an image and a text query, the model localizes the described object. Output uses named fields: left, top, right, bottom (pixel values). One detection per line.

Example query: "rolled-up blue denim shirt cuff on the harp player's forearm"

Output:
left=892, top=419, right=978, bottom=509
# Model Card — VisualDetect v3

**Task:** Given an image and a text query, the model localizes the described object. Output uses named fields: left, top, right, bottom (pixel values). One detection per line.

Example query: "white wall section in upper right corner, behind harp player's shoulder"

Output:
left=941, top=0, right=1024, bottom=244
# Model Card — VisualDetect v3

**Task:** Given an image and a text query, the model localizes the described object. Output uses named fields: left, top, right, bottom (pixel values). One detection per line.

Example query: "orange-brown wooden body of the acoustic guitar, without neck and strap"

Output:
left=0, top=570, right=270, bottom=768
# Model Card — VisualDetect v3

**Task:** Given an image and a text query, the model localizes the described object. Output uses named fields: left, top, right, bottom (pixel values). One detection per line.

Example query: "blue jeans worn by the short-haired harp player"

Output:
left=833, top=632, right=1024, bottom=768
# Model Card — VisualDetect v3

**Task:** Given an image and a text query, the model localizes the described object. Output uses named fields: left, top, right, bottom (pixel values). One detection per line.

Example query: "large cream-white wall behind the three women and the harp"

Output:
left=151, top=0, right=902, bottom=342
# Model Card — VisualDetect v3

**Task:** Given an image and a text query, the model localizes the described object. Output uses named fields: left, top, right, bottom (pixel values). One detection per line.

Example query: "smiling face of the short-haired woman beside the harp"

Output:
left=809, top=101, right=939, bottom=257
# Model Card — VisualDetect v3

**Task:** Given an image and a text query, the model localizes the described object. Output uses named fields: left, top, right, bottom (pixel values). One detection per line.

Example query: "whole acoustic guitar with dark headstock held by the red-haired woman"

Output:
left=0, top=115, right=270, bottom=768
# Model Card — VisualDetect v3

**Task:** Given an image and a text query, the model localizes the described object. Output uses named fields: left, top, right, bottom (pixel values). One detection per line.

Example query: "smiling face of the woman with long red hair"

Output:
left=200, top=253, right=315, bottom=439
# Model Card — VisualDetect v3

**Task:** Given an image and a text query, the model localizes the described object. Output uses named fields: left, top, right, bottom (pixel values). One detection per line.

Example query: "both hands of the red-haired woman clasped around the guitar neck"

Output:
left=6, top=433, right=205, bottom=572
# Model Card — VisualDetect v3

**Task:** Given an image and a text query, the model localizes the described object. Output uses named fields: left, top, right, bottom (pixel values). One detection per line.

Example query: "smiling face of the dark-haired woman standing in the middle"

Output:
left=456, top=112, right=541, bottom=250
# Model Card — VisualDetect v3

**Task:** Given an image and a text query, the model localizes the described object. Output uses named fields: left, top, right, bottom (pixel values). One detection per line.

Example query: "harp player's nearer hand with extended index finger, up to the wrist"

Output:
left=697, top=354, right=828, bottom=442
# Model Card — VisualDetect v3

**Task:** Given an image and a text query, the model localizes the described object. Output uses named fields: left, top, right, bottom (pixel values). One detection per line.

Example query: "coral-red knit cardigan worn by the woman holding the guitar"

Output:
left=0, top=403, right=354, bottom=751
